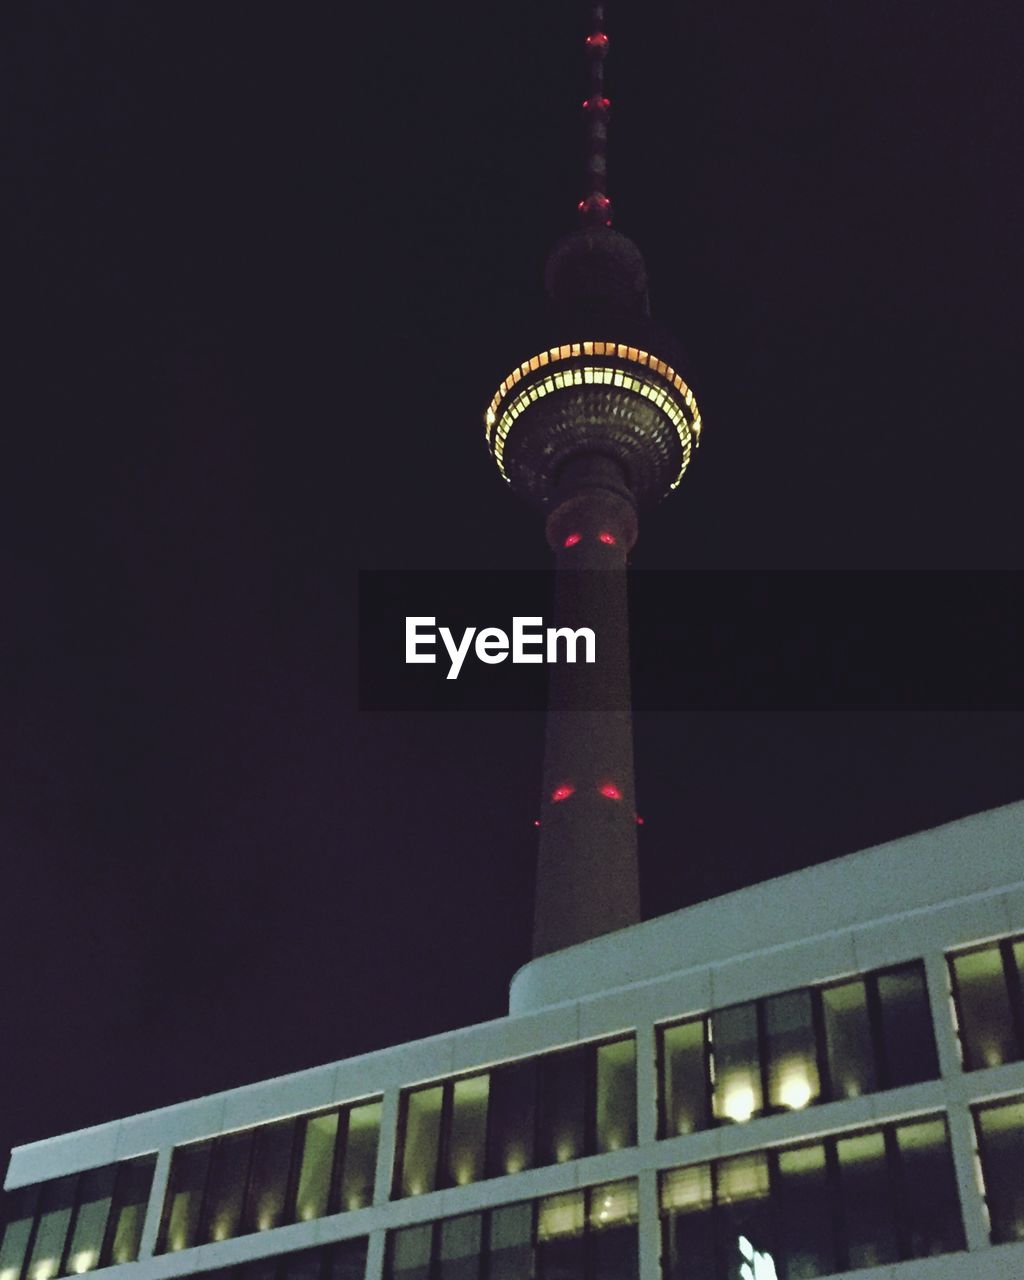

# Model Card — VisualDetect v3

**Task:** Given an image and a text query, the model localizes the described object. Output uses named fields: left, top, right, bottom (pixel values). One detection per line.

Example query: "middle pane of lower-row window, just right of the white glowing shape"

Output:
left=776, top=1143, right=838, bottom=1280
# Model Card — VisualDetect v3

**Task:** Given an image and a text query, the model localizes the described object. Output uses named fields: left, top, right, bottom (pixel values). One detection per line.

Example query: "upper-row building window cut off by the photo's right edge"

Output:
left=948, top=938, right=1024, bottom=1071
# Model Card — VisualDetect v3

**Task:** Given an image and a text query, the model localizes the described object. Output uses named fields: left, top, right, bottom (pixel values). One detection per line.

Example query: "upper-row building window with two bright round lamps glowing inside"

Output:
left=659, top=963, right=938, bottom=1138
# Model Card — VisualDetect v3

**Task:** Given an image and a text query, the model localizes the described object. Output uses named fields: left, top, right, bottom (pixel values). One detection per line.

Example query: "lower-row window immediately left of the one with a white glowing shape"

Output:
left=384, top=1180, right=639, bottom=1280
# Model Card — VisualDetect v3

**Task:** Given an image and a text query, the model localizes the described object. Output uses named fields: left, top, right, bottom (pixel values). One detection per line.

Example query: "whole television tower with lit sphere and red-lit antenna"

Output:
left=486, top=4, right=700, bottom=956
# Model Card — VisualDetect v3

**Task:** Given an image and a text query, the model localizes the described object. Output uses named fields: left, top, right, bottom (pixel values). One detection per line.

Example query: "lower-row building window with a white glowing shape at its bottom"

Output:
left=660, top=1116, right=965, bottom=1280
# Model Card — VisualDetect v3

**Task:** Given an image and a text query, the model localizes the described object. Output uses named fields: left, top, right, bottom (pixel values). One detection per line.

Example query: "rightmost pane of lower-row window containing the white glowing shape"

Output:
left=896, top=1119, right=965, bottom=1258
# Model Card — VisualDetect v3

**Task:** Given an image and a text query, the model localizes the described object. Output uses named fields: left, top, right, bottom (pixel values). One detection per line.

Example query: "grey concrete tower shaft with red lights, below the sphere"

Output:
left=534, top=454, right=640, bottom=956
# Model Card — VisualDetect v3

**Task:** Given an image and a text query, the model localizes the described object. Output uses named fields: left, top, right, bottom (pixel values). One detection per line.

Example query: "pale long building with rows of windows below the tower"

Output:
left=0, top=804, right=1024, bottom=1280
